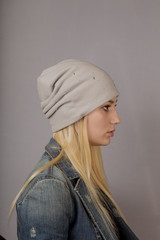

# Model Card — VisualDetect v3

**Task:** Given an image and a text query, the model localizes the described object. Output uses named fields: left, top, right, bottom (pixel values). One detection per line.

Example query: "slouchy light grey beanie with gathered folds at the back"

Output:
left=38, top=59, right=119, bottom=132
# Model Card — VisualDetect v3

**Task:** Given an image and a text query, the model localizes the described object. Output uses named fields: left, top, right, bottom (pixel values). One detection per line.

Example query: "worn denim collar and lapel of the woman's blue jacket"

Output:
left=45, top=138, right=117, bottom=240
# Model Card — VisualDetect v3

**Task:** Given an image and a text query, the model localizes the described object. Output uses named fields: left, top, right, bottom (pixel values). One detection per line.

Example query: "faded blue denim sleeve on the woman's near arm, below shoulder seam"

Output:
left=16, top=178, right=72, bottom=240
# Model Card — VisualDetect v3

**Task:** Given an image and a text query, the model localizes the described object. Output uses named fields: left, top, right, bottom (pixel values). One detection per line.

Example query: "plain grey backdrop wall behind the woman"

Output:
left=0, top=0, right=160, bottom=240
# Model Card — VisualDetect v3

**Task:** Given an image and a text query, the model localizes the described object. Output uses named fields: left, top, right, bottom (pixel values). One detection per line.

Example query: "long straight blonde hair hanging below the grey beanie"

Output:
left=9, top=116, right=123, bottom=236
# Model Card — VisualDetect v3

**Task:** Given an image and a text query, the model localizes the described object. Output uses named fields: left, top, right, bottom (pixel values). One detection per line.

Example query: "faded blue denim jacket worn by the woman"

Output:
left=16, top=138, right=138, bottom=240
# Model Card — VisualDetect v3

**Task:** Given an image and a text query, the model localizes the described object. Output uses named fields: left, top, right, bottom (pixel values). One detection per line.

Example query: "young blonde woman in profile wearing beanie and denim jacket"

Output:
left=11, top=59, right=138, bottom=240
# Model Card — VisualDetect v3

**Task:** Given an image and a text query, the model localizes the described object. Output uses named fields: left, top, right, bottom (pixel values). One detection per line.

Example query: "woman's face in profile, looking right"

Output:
left=87, top=97, right=120, bottom=146
